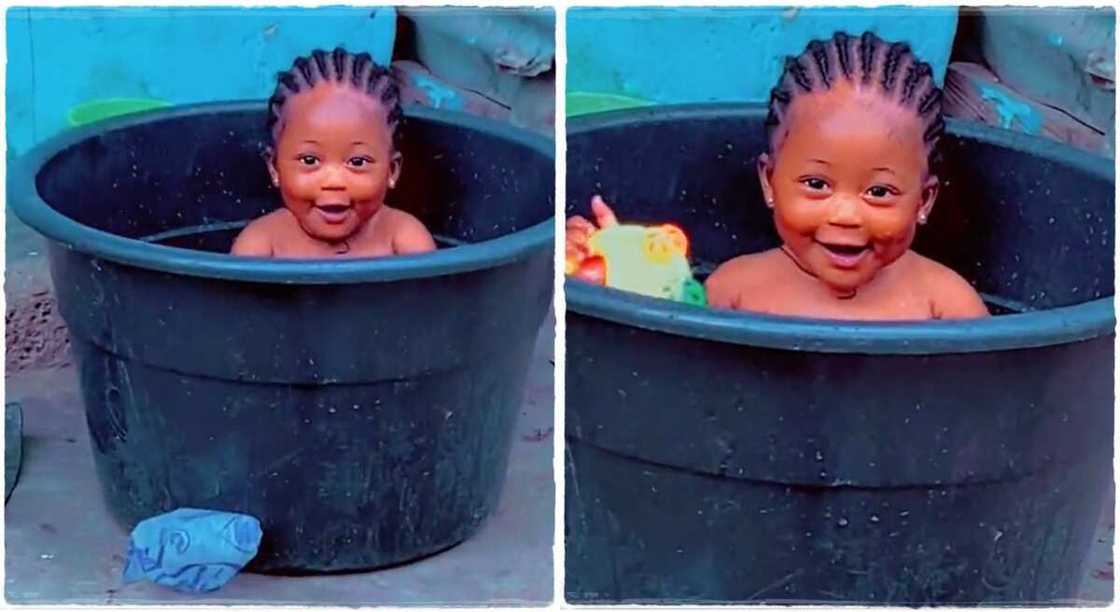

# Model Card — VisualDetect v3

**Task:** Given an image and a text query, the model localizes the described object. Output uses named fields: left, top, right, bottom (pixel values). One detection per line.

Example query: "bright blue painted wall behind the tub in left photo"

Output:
left=7, top=7, right=396, bottom=157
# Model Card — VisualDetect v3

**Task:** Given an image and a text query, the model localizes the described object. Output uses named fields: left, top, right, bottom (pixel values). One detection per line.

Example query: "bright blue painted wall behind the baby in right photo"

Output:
left=568, top=7, right=958, bottom=103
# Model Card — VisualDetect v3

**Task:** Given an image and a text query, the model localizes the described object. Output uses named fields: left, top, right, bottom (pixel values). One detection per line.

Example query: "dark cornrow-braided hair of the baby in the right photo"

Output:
left=766, top=31, right=945, bottom=171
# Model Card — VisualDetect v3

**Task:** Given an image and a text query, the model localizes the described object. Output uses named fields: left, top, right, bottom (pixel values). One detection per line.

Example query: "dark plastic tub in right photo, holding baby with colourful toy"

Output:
left=566, top=105, right=1114, bottom=603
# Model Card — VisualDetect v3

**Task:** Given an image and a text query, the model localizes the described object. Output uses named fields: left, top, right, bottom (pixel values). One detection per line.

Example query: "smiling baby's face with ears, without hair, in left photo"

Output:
left=269, top=83, right=400, bottom=242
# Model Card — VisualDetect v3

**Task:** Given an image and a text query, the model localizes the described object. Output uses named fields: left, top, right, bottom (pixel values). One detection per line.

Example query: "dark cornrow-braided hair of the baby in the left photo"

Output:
left=265, top=47, right=404, bottom=149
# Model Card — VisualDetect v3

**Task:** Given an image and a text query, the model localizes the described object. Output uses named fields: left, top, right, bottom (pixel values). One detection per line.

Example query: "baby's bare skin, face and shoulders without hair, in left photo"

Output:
left=232, top=83, right=436, bottom=259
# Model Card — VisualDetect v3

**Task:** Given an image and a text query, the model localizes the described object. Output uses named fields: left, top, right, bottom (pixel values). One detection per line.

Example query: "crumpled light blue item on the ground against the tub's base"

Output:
left=123, top=508, right=261, bottom=593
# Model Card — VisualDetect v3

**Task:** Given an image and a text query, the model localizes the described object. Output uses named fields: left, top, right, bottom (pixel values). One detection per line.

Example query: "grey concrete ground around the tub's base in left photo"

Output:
left=4, top=216, right=554, bottom=605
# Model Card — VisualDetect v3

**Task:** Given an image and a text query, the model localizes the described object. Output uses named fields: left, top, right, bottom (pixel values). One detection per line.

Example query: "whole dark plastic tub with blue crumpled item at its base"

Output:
left=9, top=102, right=553, bottom=572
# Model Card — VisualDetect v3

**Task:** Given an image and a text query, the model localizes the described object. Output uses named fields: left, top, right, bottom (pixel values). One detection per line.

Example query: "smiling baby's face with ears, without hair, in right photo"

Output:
left=759, top=82, right=936, bottom=294
